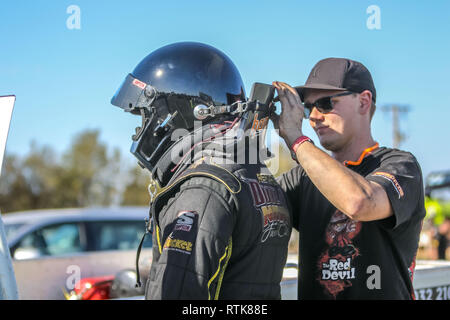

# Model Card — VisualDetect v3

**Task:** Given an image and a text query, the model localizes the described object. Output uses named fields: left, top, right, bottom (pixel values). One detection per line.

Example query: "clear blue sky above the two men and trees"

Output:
left=0, top=0, right=450, bottom=175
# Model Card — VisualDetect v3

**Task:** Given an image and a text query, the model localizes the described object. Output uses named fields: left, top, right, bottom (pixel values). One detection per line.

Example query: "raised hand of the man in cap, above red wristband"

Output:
left=271, top=81, right=304, bottom=148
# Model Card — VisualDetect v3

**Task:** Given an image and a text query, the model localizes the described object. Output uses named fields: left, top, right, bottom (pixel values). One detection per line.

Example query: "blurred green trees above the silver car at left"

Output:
left=0, top=130, right=128, bottom=212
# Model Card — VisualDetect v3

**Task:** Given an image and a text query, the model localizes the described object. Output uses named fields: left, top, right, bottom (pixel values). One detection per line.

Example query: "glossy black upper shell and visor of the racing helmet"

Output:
left=111, top=42, right=245, bottom=128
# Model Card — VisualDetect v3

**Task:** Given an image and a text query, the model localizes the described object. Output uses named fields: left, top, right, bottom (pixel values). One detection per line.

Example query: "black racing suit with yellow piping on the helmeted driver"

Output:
left=146, top=157, right=292, bottom=300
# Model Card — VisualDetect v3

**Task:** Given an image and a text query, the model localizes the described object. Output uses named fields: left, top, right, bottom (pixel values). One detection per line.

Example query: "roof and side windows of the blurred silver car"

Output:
left=2, top=207, right=151, bottom=260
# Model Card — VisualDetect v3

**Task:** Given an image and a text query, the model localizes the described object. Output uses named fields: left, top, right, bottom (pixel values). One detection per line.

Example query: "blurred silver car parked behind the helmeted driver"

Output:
left=2, top=207, right=152, bottom=300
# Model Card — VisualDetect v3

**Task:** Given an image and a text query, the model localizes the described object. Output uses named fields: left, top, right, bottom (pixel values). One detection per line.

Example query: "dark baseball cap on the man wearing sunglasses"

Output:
left=295, top=58, right=377, bottom=102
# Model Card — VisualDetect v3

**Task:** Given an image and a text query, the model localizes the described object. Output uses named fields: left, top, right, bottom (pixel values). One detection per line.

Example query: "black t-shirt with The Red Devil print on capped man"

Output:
left=279, top=147, right=425, bottom=299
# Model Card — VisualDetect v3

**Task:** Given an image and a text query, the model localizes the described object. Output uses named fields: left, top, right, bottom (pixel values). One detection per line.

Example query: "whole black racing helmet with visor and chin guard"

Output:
left=111, top=42, right=246, bottom=172
